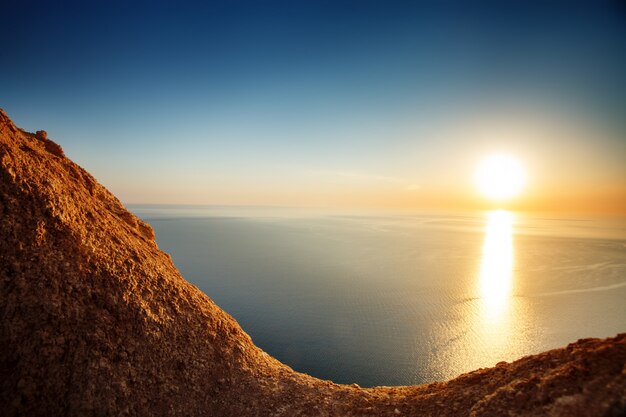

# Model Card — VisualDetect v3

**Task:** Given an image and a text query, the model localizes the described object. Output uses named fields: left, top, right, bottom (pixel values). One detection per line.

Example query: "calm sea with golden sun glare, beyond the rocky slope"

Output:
left=130, top=205, right=626, bottom=387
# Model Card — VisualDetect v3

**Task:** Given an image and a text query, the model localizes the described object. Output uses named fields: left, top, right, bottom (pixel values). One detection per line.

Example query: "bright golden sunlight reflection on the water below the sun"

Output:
left=430, top=210, right=527, bottom=380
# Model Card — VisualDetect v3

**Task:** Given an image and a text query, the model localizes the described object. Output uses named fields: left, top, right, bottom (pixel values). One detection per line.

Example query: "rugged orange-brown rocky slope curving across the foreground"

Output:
left=0, top=111, right=626, bottom=417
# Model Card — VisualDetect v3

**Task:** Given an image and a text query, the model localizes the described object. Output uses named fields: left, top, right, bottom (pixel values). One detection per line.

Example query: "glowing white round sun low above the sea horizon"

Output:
left=474, top=154, right=526, bottom=201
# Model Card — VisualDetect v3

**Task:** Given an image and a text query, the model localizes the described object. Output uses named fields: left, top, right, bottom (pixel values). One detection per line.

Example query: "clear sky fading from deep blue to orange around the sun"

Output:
left=0, top=0, right=626, bottom=214
